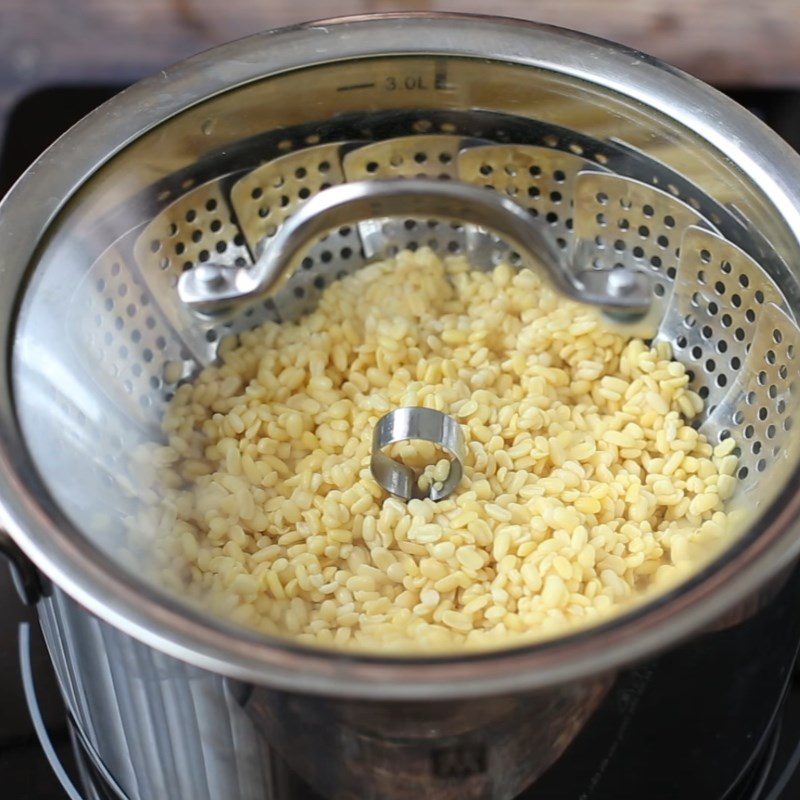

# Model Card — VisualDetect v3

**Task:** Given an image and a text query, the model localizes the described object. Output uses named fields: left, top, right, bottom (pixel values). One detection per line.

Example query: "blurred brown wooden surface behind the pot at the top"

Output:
left=0, top=0, right=800, bottom=143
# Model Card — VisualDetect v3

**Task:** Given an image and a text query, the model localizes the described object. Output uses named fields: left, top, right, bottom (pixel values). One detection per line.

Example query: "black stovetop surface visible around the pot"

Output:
left=0, top=86, right=800, bottom=800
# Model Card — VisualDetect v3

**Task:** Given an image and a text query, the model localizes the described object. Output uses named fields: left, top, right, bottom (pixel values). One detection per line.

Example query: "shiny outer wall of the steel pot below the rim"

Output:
left=39, top=588, right=612, bottom=800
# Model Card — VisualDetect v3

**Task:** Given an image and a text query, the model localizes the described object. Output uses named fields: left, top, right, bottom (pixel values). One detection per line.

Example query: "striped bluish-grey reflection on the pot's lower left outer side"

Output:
left=39, top=590, right=273, bottom=800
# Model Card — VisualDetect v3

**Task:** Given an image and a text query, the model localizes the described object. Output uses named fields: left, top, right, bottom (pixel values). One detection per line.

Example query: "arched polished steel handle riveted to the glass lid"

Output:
left=178, top=178, right=652, bottom=320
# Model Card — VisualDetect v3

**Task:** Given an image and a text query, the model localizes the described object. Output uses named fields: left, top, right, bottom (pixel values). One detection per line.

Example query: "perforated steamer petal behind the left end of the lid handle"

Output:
left=134, top=178, right=252, bottom=363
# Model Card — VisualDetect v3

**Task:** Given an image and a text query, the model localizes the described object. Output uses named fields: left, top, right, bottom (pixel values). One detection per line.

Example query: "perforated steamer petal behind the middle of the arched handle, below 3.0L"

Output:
left=343, top=134, right=470, bottom=259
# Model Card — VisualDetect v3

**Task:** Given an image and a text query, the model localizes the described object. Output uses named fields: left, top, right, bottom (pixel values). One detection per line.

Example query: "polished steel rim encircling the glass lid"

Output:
left=0, top=12, right=800, bottom=699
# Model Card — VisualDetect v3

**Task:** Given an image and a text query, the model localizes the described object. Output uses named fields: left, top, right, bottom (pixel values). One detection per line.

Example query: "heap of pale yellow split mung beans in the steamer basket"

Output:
left=128, top=250, right=736, bottom=652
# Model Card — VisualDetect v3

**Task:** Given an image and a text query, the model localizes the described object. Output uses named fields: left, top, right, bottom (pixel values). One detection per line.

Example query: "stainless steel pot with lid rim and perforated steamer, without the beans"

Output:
left=0, top=14, right=800, bottom=800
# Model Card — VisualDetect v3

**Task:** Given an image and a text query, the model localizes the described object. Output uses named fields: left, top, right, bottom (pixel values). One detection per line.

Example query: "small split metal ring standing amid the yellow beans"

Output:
left=370, top=407, right=466, bottom=500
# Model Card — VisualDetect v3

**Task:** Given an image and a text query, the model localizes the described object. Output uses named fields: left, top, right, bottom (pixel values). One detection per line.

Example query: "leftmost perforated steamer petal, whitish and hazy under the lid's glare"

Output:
left=67, top=237, right=190, bottom=427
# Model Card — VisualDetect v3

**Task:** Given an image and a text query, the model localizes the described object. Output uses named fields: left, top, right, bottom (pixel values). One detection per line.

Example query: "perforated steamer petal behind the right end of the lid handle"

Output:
left=575, top=172, right=713, bottom=314
